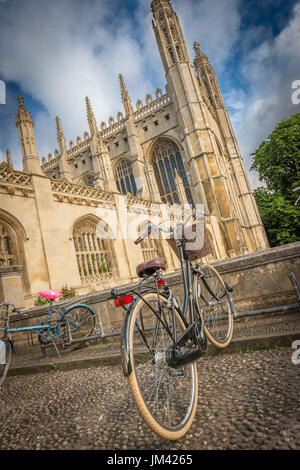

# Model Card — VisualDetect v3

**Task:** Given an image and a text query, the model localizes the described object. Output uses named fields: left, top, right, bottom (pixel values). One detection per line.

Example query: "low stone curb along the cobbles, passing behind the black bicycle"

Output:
left=7, top=330, right=300, bottom=377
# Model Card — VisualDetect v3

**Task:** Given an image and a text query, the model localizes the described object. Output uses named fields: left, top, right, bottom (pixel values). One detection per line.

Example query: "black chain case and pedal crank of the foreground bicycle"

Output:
left=165, top=322, right=207, bottom=369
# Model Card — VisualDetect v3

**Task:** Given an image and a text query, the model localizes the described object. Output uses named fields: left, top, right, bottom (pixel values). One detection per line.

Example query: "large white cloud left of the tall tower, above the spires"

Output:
left=0, top=0, right=158, bottom=166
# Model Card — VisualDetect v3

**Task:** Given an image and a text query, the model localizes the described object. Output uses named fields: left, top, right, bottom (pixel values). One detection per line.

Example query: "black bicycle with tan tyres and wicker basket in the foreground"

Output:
left=111, top=213, right=234, bottom=440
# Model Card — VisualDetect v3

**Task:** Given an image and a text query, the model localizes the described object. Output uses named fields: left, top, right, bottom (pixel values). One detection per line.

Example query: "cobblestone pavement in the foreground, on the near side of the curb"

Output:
left=0, top=349, right=300, bottom=450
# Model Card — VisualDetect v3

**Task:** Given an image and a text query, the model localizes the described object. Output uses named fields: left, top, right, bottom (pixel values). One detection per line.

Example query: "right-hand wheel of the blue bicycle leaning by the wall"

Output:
left=62, top=305, right=96, bottom=339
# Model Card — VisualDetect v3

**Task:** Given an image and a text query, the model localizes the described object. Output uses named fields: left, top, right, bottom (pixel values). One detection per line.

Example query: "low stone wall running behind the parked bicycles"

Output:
left=11, top=242, right=300, bottom=345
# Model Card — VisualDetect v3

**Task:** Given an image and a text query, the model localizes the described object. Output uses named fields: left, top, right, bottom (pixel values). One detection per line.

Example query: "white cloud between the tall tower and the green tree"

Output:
left=225, top=3, right=300, bottom=186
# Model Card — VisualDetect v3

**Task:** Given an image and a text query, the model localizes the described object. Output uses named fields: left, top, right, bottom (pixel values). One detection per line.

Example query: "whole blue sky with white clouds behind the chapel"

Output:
left=0, top=0, right=300, bottom=186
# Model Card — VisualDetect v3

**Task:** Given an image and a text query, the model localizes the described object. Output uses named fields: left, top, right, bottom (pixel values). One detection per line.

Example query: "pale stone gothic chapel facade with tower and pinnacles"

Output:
left=0, top=0, right=268, bottom=306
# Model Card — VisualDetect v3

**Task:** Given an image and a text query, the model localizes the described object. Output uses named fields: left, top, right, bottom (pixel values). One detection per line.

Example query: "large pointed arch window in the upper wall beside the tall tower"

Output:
left=152, top=140, right=193, bottom=205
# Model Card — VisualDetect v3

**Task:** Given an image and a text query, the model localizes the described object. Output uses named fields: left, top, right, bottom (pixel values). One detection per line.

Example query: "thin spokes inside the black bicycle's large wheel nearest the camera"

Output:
left=127, top=294, right=195, bottom=431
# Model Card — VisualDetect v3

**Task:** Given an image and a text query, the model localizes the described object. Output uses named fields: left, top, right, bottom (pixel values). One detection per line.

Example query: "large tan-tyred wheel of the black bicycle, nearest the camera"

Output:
left=128, top=292, right=198, bottom=440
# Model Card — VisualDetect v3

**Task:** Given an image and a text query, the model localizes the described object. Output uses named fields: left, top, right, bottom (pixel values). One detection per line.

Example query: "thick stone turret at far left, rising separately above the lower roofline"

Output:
left=16, top=95, right=43, bottom=175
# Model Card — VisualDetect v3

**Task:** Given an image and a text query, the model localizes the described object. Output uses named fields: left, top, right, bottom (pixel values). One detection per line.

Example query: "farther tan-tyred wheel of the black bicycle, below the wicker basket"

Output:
left=194, top=263, right=234, bottom=348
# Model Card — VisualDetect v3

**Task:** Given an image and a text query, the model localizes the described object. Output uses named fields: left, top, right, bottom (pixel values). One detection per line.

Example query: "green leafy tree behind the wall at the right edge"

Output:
left=251, top=113, right=300, bottom=246
